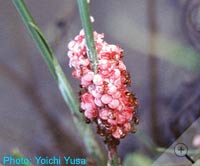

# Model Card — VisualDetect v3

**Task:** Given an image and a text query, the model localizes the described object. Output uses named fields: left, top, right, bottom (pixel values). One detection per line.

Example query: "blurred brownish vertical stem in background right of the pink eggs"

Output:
left=147, top=0, right=160, bottom=145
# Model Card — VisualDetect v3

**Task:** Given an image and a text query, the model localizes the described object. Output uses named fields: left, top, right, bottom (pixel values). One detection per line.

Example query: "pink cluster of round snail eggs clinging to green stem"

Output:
left=68, top=30, right=139, bottom=139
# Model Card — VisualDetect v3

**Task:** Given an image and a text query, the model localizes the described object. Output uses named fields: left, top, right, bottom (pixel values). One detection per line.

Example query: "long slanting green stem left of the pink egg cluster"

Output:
left=12, top=0, right=105, bottom=165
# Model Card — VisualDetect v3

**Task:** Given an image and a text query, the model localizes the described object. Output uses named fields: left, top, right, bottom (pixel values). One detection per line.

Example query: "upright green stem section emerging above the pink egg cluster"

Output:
left=77, top=0, right=98, bottom=73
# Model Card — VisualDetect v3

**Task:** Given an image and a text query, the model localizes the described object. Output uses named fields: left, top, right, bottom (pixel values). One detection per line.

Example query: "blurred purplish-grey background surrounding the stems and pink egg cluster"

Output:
left=0, top=0, right=200, bottom=165
